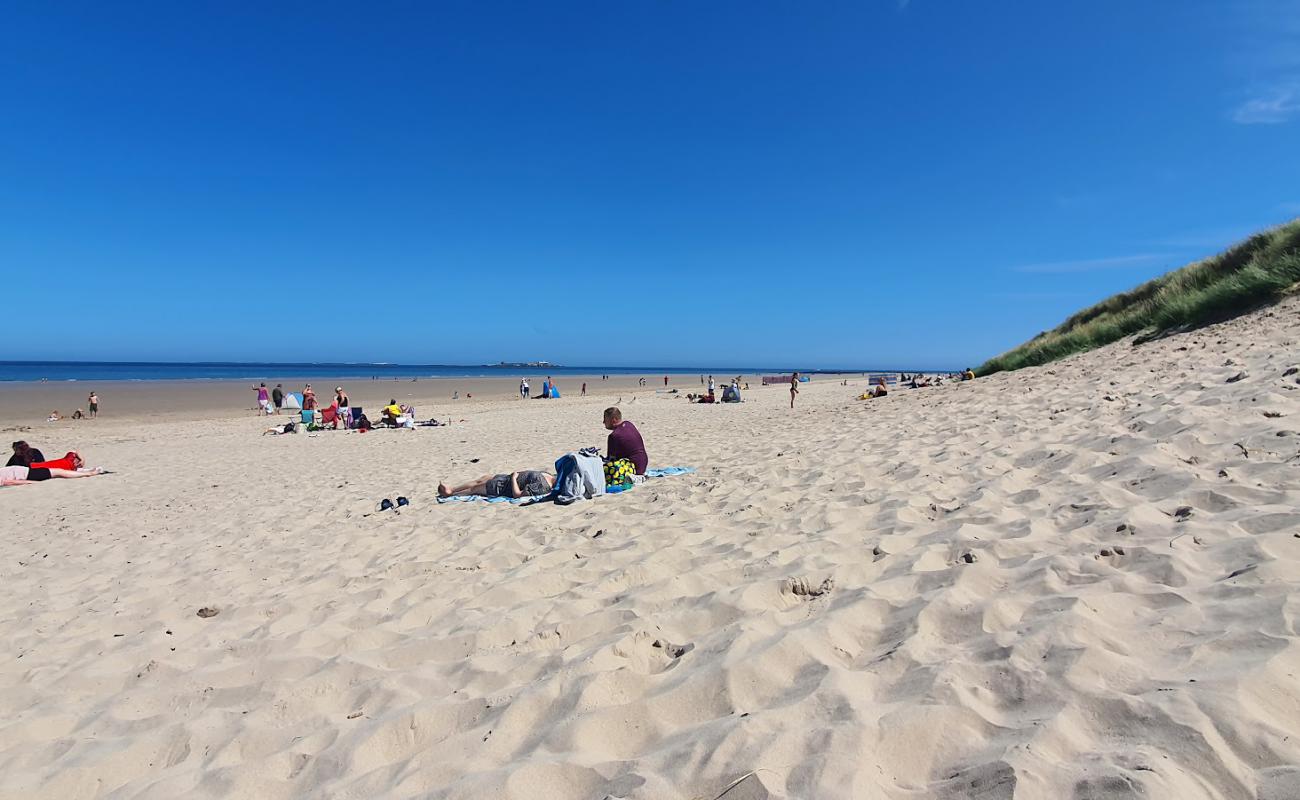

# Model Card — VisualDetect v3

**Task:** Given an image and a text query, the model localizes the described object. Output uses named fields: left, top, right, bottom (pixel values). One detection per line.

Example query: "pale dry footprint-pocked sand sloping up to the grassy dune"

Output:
left=0, top=299, right=1300, bottom=800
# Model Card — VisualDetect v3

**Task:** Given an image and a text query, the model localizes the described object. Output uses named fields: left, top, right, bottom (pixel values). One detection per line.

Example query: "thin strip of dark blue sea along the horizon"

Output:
left=0, top=362, right=857, bottom=382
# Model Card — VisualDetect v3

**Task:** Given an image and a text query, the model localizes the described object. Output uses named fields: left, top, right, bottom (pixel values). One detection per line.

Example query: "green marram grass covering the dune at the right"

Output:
left=978, top=219, right=1300, bottom=375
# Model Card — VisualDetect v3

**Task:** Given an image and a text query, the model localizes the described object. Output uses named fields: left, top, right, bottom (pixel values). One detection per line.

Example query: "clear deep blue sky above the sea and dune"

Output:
left=0, top=0, right=1300, bottom=367
